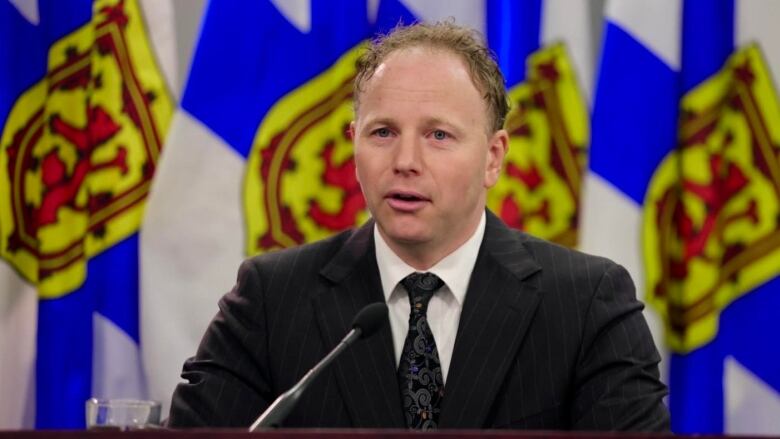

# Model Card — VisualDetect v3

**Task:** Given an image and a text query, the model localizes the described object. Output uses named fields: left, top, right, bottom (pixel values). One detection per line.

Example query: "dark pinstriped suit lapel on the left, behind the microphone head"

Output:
left=314, top=222, right=405, bottom=428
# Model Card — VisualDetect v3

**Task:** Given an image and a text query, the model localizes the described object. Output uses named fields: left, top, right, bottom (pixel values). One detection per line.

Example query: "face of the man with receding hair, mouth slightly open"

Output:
left=352, top=47, right=507, bottom=269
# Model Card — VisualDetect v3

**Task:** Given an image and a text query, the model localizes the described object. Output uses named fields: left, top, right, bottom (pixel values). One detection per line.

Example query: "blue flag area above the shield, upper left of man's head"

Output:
left=182, top=0, right=369, bottom=157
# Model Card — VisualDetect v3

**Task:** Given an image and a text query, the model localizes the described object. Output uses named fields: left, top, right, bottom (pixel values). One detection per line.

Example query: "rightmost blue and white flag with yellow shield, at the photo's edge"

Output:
left=584, top=0, right=780, bottom=434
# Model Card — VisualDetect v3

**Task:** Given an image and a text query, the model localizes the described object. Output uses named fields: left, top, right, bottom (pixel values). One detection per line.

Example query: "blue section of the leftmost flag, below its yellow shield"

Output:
left=35, top=234, right=144, bottom=428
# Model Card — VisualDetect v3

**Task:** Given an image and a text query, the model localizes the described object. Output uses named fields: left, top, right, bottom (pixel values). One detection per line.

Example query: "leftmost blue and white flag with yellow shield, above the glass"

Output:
left=0, top=0, right=172, bottom=428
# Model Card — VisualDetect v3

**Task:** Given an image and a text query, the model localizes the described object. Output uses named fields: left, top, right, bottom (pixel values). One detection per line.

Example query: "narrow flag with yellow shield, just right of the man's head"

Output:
left=486, top=0, right=601, bottom=247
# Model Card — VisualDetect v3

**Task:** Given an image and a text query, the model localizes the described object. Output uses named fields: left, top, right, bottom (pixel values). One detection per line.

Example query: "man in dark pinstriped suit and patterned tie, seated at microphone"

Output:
left=169, top=23, right=669, bottom=430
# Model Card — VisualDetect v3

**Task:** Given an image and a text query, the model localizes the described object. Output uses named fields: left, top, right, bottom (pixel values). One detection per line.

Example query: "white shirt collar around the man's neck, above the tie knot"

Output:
left=374, top=212, right=485, bottom=306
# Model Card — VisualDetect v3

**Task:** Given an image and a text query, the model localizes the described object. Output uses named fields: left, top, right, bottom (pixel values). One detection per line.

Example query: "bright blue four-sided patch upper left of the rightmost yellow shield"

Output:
left=589, top=22, right=679, bottom=205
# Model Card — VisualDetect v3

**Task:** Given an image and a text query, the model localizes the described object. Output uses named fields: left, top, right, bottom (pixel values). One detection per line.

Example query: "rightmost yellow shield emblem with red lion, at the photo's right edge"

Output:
left=644, top=46, right=780, bottom=353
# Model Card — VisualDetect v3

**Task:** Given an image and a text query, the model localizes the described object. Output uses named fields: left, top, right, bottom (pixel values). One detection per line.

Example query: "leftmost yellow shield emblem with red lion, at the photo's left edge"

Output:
left=0, top=0, right=172, bottom=298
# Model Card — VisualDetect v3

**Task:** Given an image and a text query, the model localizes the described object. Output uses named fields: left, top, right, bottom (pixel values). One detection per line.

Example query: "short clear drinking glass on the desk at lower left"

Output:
left=86, top=398, right=161, bottom=431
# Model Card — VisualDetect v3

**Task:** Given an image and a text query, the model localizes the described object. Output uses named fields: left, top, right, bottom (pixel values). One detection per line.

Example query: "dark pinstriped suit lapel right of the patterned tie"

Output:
left=439, top=212, right=540, bottom=428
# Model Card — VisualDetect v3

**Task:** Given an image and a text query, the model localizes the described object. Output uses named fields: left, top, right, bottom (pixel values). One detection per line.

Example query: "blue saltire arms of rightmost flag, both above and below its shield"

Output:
left=590, top=0, right=780, bottom=433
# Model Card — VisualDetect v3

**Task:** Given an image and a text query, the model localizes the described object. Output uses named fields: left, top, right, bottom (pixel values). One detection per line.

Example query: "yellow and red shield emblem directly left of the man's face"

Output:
left=244, top=46, right=368, bottom=254
